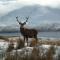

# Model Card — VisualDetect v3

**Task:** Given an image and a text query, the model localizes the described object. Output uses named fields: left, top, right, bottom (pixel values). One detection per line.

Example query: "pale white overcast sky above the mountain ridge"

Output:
left=0, top=0, right=60, bottom=16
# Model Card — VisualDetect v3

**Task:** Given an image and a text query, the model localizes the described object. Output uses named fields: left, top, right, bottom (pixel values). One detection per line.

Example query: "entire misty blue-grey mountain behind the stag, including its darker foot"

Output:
left=0, top=5, right=60, bottom=31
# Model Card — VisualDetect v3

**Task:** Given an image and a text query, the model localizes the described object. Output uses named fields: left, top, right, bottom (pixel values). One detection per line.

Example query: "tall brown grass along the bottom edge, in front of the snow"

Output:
left=5, top=46, right=55, bottom=60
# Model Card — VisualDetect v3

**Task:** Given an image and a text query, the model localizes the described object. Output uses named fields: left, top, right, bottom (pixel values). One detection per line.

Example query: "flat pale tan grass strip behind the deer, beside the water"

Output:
left=0, top=36, right=60, bottom=46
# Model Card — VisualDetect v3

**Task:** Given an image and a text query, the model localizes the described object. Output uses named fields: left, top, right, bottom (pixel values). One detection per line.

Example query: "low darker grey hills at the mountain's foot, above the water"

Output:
left=0, top=23, right=60, bottom=33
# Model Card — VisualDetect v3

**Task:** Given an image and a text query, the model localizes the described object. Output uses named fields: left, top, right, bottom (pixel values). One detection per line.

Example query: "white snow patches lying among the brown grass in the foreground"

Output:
left=0, top=38, right=60, bottom=57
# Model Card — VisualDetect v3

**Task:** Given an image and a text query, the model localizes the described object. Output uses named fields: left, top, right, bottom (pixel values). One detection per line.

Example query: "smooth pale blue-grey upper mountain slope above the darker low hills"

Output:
left=0, top=5, right=60, bottom=25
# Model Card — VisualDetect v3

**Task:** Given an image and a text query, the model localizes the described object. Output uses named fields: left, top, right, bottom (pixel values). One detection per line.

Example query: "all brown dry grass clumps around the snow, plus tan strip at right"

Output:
left=0, top=36, right=60, bottom=60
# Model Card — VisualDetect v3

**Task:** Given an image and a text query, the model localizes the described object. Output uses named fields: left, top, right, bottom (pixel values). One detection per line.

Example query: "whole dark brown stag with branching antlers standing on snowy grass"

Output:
left=16, top=17, right=38, bottom=46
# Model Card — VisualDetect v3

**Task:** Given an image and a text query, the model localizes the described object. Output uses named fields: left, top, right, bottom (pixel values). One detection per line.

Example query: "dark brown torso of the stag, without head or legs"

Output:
left=20, top=28, right=37, bottom=38
